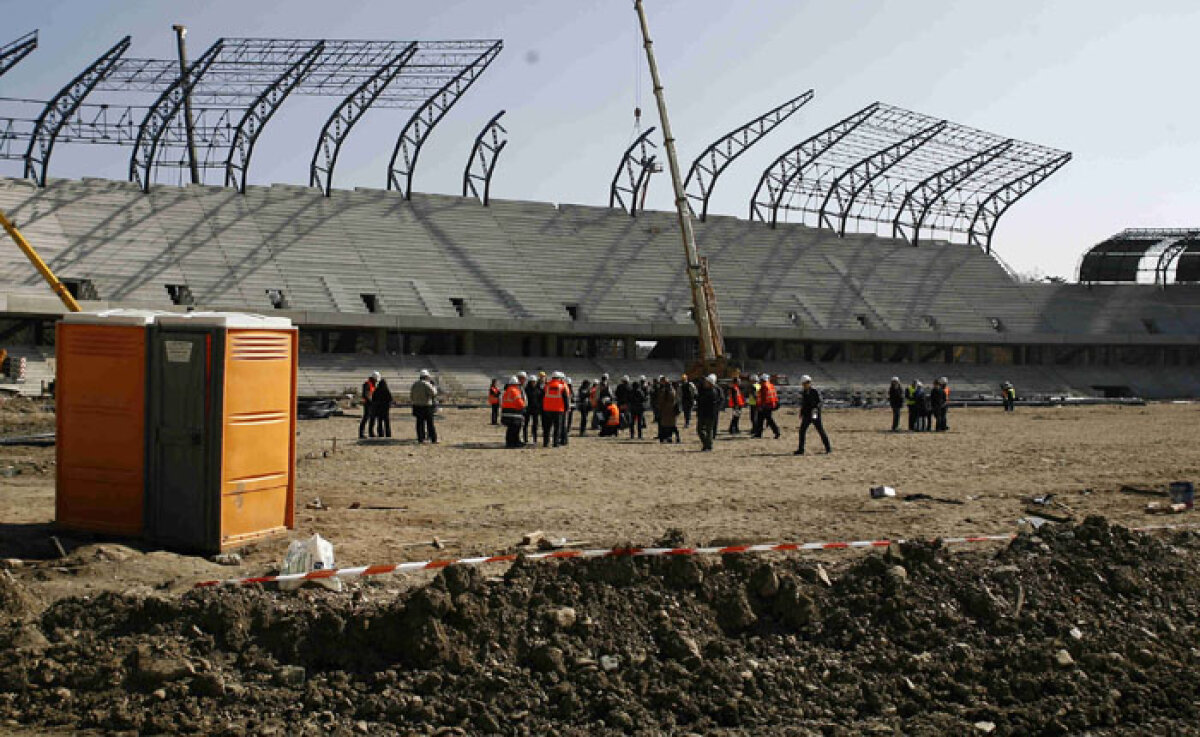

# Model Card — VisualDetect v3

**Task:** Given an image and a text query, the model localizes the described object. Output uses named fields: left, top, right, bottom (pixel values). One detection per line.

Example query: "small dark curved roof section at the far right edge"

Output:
left=1079, top=228, right=1200, bottom=286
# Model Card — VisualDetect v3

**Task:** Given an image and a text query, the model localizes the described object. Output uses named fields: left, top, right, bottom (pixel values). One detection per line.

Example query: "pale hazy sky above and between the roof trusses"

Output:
left=0, top=0, right=1200, bottom=276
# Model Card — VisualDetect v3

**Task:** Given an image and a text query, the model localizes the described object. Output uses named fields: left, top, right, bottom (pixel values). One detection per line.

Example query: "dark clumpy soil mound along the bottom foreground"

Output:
left=0, top=519, right=1200, bottom=735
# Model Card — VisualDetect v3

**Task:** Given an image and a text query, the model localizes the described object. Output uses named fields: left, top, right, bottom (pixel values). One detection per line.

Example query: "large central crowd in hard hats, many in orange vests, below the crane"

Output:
left=487, top=371, right=832, bottom=455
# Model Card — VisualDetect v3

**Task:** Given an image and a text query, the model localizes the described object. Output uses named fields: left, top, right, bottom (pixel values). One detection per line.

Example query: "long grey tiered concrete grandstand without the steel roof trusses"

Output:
left=0, top=179, right=1200, bottom=399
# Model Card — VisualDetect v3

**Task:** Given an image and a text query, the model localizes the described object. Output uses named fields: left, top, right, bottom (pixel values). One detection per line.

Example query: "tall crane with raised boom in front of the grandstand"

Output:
left=634, top=0, right=726, bottom=377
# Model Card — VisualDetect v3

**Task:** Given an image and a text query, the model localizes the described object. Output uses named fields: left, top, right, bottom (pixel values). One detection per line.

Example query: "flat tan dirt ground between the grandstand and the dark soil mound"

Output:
left=0, top=405, right=1200, bottom=600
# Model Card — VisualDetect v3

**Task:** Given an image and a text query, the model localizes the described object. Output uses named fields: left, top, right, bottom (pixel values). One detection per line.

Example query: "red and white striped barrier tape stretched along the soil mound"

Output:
left=196, top=525, right=1200, bottom=588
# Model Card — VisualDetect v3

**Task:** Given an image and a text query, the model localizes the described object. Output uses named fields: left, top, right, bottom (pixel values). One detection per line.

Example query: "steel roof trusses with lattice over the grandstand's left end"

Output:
left=0, top=36, right=503, bottom=194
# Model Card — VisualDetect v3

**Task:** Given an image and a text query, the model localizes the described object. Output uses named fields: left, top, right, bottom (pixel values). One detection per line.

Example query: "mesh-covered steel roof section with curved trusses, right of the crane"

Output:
left=750, top=102, right=1070, bottom=252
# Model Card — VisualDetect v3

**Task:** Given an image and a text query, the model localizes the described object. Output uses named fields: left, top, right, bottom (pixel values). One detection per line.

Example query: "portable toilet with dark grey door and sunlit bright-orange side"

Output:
left=145, top=312, right=298, bottom=552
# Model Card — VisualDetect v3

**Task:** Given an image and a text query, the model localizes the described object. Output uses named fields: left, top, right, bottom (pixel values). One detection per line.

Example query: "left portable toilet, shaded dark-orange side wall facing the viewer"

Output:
left=54, top=310, right=162, bottom=535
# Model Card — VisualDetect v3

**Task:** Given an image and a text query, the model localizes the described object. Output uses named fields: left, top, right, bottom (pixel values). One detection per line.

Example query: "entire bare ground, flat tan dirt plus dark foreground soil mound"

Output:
left=0, top=403, right=1200, bottom=735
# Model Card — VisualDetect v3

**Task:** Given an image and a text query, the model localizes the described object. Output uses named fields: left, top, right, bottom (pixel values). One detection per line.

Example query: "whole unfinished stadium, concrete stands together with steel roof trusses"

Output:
left=0, top=34, right=1200, bottom=397
